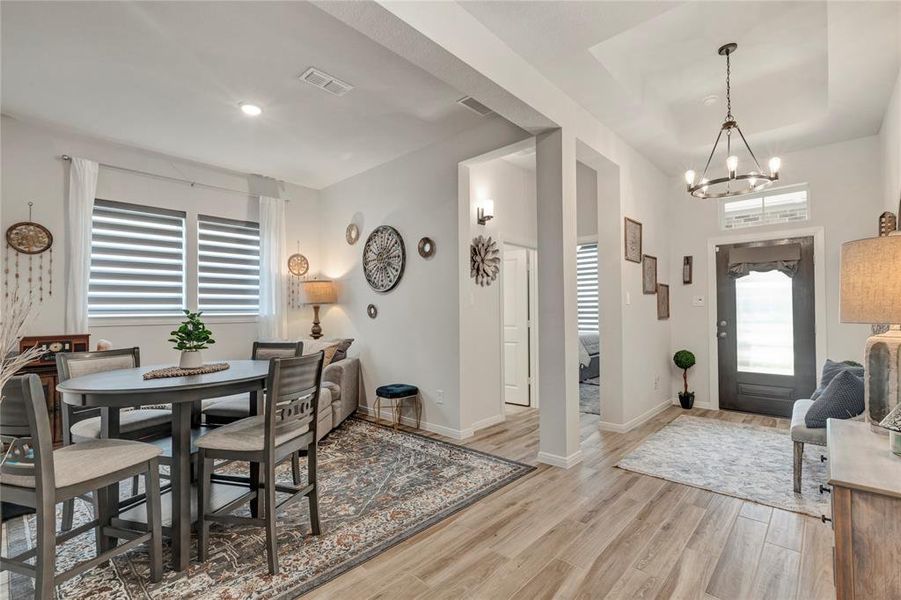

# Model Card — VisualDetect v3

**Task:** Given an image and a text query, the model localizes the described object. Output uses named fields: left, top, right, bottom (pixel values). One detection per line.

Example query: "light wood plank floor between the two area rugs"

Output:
left=307, top=407, right=835, bottom=600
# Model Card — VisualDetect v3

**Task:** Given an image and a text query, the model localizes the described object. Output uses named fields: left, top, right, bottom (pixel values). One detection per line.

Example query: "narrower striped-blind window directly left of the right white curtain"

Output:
left=197, top=215, right=260, bottom=315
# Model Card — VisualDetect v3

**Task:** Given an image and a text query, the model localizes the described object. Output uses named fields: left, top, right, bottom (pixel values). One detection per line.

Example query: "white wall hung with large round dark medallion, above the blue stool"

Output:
left=320, top=117, right=527, bottom=437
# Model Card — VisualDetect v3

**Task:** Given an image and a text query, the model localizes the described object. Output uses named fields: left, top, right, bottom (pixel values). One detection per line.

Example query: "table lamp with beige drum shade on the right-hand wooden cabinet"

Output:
left=841, top=233, right=901, bottom=432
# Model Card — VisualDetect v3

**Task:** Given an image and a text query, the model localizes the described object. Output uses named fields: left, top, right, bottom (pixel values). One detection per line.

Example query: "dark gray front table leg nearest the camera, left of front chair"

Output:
left=170, top=402, right=191, bottom=571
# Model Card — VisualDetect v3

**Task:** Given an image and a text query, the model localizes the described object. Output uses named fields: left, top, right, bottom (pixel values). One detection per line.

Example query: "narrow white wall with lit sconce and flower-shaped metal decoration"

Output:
left=460, top=150, right=538, bottom=430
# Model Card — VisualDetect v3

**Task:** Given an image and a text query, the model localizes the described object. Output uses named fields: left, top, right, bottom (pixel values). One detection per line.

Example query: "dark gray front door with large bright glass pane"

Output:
left=716, top=237, right=816, bottom=417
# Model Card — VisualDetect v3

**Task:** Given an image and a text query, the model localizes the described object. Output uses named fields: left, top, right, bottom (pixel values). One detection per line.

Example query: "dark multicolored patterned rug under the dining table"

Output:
left=0, top=418, right=533, bottom=600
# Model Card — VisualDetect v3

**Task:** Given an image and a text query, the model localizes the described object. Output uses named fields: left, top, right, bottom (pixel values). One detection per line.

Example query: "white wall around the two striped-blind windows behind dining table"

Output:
left=0, top=116, right=320, bottom=364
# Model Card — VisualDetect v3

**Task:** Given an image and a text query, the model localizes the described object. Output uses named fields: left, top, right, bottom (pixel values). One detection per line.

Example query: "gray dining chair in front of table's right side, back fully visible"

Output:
left=197, top=352, right=324, bottom=575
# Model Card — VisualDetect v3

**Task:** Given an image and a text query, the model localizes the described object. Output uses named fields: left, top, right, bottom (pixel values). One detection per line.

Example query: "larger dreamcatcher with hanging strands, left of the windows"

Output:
left=3, top=202, right=53, bottom=302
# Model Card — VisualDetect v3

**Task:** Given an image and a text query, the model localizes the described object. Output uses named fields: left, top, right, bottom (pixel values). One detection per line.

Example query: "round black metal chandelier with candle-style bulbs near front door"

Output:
left=685, top=43, right=782, bottom=198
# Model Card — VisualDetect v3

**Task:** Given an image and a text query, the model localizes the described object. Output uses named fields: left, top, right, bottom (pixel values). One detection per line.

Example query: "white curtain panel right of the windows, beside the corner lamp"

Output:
left=258, top=196, right=288, bottom=341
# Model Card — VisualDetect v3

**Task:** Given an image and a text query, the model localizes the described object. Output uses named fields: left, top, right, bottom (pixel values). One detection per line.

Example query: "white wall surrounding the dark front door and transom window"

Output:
left=666, top=136, right=883, bottom=405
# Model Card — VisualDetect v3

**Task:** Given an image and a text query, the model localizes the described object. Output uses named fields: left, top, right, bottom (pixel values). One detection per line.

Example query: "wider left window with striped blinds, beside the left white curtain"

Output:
left=88, top=199, right=185, bottom=317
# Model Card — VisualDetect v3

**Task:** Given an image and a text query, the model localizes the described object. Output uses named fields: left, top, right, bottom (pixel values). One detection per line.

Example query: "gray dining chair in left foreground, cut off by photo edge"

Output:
left=0, top=373, right=163, bottom=600
